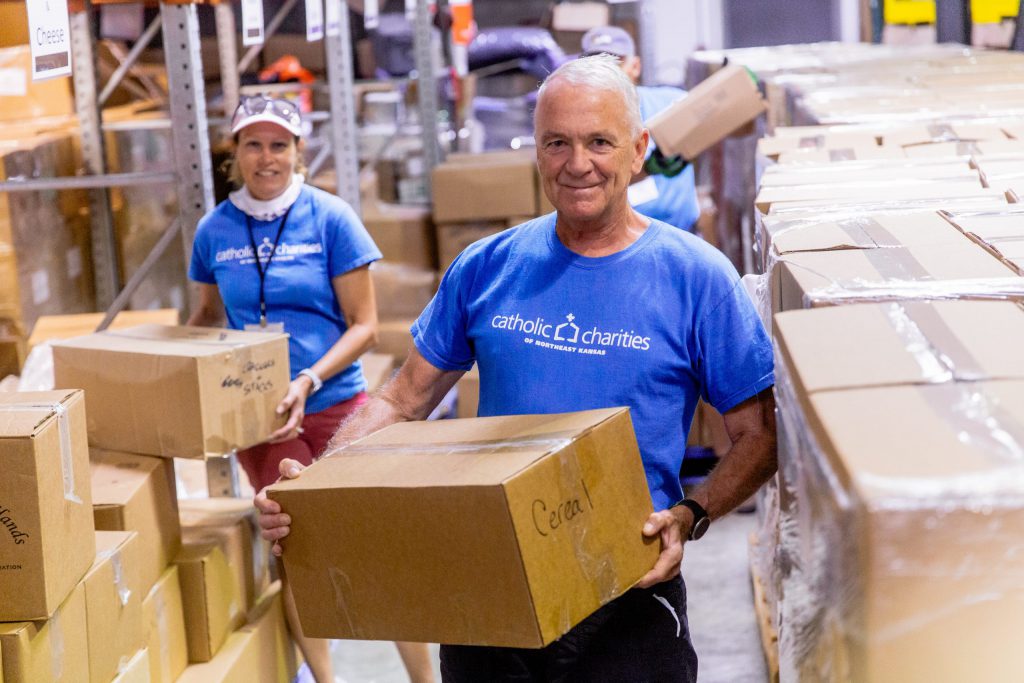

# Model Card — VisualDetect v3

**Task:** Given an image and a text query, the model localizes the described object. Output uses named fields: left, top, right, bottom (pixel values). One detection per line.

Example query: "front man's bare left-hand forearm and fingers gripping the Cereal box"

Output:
left=255, top=348, right=463, bottom=556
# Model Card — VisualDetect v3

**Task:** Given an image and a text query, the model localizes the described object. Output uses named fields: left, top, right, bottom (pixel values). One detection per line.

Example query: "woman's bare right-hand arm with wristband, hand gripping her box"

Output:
left=270, top=265, right=377, bottom=441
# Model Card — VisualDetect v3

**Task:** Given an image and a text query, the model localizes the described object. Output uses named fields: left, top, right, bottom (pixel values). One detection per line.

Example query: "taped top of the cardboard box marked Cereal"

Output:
left=271, top=409, right=628, bottom=490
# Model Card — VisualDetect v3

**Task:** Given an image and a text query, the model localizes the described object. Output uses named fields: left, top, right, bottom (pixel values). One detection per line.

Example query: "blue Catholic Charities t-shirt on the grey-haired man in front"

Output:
left=413, top=214, right=774, bottom=509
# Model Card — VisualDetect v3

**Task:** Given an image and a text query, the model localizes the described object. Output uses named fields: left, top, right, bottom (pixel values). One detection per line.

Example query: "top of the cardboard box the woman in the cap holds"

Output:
left=54, top=324, right=287, bottom=357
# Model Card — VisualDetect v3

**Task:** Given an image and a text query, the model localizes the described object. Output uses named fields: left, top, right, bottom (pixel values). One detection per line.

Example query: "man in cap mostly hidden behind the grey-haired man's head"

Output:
left=583, top=26, right=700, bottom=232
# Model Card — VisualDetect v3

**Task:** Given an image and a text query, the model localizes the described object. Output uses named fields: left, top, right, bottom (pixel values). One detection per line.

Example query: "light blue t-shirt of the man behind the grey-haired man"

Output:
left=633, top=85, right=700, bottom=232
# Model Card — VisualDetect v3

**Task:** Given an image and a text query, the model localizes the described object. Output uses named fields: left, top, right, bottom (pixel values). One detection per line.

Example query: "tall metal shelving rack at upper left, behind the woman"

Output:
left=0, top=0, right=370, bottom=496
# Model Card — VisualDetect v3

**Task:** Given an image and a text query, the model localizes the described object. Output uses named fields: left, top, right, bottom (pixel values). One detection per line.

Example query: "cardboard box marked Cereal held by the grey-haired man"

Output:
left=268, top=409, right=658, bottom=647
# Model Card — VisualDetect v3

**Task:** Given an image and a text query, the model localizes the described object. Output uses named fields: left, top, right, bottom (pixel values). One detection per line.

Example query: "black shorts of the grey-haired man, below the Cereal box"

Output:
left=441, top=577, right=697, bottom=683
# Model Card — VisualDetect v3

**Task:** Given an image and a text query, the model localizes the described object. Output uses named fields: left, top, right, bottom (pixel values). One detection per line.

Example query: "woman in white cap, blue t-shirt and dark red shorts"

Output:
left=188, top=96, right=432, bottom=683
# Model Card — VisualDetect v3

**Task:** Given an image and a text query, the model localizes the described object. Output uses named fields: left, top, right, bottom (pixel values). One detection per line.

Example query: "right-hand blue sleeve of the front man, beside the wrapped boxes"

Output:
left=696, top=266, right=775, bottom=413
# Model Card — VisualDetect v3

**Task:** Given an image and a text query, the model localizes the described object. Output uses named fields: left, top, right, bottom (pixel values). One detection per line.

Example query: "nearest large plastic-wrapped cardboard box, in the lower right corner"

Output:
left=761, top=300, right=1024, bottom=681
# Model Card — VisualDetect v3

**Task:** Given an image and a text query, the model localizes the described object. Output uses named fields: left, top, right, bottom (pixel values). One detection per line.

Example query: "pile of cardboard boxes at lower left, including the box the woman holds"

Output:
left=0, top=325, right=297, bottom=683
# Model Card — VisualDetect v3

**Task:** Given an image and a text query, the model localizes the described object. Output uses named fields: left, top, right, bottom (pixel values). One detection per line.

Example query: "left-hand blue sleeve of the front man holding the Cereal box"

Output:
left=412, top=252, right=475, bottom=371
